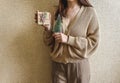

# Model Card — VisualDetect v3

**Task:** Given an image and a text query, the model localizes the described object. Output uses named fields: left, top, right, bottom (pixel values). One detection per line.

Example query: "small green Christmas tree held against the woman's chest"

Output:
left=53, top=14, right=62, bottom=32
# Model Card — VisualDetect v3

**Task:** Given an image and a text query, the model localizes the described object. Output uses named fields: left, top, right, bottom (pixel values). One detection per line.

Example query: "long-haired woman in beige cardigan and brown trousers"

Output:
left=35, top=0, right=99, bottom=83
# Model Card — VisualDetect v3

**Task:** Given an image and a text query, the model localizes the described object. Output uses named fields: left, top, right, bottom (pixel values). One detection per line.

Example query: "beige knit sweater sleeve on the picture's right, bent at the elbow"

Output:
left=67, top=9, right=99, bottom=58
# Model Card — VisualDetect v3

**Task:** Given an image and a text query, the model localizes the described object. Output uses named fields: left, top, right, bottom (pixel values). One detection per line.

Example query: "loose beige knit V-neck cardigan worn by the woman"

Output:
left=43, top=6, right=99, bottom=63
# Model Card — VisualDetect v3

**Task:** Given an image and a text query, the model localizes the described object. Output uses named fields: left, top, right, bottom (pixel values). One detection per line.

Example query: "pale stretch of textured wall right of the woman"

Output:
left=91, top=0, right=120, bottom=83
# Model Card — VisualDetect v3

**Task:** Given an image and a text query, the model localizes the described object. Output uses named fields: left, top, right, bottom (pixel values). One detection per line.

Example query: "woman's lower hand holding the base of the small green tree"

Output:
left=53, top=33, right=68, bottom=43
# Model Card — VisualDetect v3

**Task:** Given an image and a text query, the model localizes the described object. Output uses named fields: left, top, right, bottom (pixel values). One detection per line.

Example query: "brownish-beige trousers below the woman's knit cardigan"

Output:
left=52, top=59, right=90, bottom=83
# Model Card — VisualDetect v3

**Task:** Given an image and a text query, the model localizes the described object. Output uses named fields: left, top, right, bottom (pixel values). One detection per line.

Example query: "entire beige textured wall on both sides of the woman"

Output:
left=0, top=0, right=120, bottom=83
